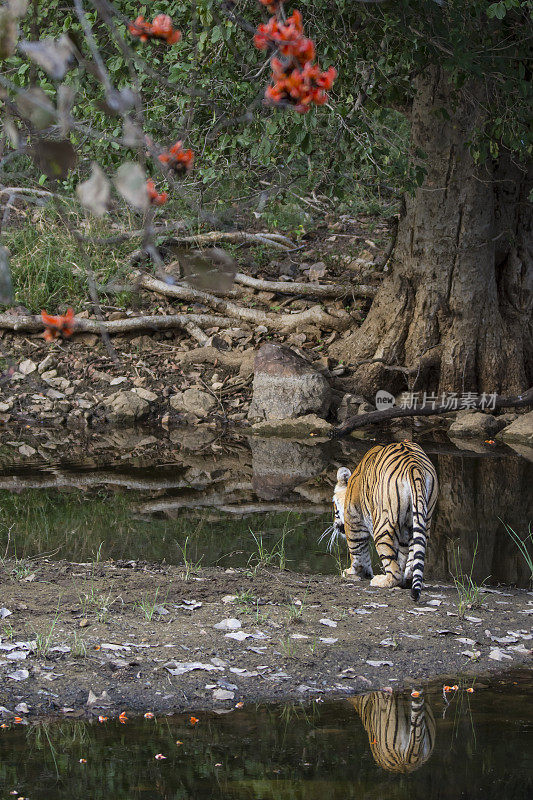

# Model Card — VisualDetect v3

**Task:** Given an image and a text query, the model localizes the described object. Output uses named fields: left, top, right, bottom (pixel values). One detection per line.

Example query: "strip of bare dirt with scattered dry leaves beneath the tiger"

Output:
left=0, top=560, right=533, bottom=724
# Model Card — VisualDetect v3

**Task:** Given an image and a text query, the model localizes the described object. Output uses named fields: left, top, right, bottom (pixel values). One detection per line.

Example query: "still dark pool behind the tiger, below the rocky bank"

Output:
left=0, top=431, right=533, bottom=587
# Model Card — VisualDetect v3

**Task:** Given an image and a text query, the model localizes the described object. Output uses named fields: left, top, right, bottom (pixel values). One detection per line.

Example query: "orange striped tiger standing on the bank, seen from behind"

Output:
left=322, top=441, right=438, bottom=602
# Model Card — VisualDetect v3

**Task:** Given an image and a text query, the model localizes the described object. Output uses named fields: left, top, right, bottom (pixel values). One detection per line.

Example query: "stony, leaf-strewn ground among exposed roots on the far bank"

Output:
left=0, top=209, right=392, bottom=428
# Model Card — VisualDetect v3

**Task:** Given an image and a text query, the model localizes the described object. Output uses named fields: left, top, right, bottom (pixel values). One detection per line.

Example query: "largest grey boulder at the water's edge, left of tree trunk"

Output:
left=248, top=342, right=331, bottom=422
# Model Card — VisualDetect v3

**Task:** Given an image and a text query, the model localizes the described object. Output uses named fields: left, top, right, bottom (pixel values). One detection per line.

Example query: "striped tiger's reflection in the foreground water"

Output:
left=348, top=692, right=435, bottom=773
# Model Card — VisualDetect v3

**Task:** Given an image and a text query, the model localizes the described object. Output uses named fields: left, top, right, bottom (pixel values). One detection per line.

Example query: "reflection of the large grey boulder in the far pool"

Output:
left=250, top=437, right=326, bottom=500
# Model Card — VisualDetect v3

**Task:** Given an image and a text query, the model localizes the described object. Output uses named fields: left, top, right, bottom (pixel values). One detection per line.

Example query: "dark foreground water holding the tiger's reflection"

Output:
left=0, top=673, right=533, bottom=800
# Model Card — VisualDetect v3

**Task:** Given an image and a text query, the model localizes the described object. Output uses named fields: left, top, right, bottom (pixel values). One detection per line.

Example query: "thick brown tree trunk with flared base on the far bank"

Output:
left=333, top=67, right=533, bottom=396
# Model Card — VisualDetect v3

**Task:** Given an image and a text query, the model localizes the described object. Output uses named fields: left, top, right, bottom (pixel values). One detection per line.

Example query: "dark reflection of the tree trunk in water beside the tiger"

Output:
left=426, top=455, right=533, bottom=586
